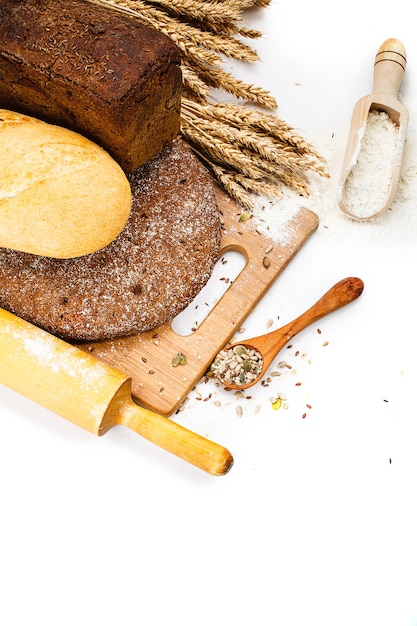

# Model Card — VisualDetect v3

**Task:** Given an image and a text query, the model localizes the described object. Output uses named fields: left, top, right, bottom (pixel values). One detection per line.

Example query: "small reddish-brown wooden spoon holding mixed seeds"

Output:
left=213, top=278, right=364, bottom=389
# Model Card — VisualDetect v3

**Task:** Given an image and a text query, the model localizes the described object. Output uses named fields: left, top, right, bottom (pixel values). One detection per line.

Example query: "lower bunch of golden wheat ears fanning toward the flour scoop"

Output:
left=181, top=98, right=328, bottom=209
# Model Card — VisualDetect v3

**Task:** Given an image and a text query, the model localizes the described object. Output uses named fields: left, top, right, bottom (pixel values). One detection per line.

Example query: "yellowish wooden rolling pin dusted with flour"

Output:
left=0, top=309, right=233, bottom=476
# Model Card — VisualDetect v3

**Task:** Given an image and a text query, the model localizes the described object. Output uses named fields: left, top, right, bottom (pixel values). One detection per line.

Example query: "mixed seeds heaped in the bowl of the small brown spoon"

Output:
left=211, top=344, right=263, bottom=386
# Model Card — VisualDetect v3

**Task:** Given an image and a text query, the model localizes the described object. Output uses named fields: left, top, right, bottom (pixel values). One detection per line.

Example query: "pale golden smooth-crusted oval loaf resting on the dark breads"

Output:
left=0, top=109, right=132, bottom=258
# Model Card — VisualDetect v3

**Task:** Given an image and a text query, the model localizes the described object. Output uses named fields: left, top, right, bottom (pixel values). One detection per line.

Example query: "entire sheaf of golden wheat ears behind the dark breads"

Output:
left=92, top=0, right=328, bottom=210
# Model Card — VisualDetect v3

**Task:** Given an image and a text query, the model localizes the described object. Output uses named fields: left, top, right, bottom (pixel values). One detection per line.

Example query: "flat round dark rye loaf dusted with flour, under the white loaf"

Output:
left=0, top=139, right=221, bottom=341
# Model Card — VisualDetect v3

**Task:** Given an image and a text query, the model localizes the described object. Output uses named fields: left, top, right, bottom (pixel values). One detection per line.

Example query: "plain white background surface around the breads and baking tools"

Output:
left=0, top=0, right=417, bottom=626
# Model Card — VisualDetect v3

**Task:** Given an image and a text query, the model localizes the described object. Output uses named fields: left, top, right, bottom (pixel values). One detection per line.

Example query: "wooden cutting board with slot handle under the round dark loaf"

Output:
left=79, top=190, right=318, bottom=416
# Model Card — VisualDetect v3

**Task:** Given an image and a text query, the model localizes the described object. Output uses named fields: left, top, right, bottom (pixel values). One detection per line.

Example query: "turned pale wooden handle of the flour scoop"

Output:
left=374, top=39, right=407, bottom=98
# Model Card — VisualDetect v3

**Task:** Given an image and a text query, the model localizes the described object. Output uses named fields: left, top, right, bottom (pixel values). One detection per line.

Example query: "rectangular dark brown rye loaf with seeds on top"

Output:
left=0, top=0, right=181, bottom=172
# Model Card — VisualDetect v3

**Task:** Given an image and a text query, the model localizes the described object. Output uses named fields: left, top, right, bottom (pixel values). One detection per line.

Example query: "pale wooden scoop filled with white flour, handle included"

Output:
left=337, top=39, right=408, bottom=221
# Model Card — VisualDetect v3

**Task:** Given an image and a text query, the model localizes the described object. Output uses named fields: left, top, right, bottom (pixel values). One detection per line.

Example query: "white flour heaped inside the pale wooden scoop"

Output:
left=345, top=111, right=399, bottom=219
